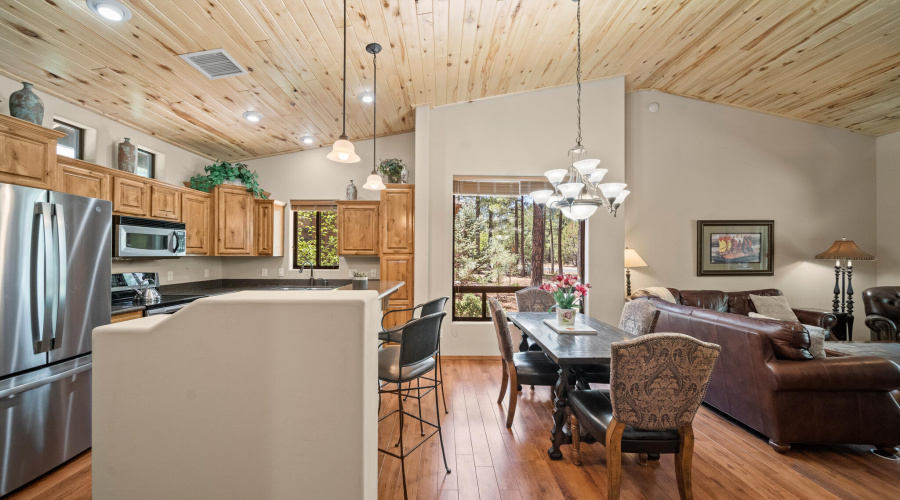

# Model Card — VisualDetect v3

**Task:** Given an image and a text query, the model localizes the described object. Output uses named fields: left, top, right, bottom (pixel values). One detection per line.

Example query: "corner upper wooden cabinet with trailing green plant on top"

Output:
left=214, top=185, right=255, bottom=255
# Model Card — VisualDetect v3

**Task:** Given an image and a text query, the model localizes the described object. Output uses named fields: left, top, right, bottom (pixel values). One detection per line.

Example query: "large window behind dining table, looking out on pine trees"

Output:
left=453, top=179, right=585, bottom=321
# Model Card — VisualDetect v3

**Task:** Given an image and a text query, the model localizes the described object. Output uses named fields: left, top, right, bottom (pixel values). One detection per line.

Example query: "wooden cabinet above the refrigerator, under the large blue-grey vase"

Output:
left=0, top=115, right=66, bottom=189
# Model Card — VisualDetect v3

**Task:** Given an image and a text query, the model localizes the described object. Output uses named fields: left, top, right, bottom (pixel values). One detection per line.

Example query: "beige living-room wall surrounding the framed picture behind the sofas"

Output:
left=625, top=91, right=876, bottom=339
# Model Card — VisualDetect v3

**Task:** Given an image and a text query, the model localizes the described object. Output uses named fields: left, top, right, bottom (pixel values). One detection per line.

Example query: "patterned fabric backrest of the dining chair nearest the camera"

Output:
left=609, top=333, right=721, bottom=430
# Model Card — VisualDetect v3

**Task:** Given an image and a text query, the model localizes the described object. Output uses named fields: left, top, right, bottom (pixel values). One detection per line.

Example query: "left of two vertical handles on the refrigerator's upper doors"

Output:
left=31, top=202, right=53, bottom=354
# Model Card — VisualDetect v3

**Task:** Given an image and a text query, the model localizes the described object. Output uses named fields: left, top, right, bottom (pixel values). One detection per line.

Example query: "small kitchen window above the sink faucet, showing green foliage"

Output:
left=294, top=209, right=338, bottom=269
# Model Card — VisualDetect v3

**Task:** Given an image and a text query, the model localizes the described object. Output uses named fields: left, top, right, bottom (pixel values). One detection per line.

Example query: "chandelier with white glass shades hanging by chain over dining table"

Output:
left=529, top=0, right=630, bottom=221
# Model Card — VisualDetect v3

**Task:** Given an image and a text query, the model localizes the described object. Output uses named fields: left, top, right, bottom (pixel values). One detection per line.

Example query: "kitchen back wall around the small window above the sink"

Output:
left=221, top=132, right=415, bottom=279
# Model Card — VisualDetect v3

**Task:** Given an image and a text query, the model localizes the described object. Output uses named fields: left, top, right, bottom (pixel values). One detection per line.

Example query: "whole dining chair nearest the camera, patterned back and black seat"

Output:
left=568, top=333, right=720, bottom=500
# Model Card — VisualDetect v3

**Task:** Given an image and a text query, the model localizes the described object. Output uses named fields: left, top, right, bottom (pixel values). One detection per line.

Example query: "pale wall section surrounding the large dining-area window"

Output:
left=424, top=77, right=625, bottom=355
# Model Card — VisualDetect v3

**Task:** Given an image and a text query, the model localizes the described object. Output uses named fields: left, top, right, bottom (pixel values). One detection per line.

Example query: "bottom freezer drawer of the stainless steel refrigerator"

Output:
left=0, top=355, right=91, bottom=496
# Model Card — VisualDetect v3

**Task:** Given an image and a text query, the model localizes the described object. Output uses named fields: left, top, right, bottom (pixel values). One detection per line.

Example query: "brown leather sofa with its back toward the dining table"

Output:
left=649, top=290, right=900, bottom=453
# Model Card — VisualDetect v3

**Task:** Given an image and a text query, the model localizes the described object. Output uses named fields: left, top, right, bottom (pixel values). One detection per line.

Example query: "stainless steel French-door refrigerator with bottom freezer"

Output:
left=0, top=184, right=112, bottom=495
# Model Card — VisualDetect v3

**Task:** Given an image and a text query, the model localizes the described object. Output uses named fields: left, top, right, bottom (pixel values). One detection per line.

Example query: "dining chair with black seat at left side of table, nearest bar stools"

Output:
left=488, top=297, right=559, bottom=427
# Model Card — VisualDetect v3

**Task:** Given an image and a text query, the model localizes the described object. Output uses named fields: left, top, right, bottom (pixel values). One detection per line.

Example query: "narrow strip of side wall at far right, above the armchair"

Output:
left=875, top=132, right=900, bottom=286
